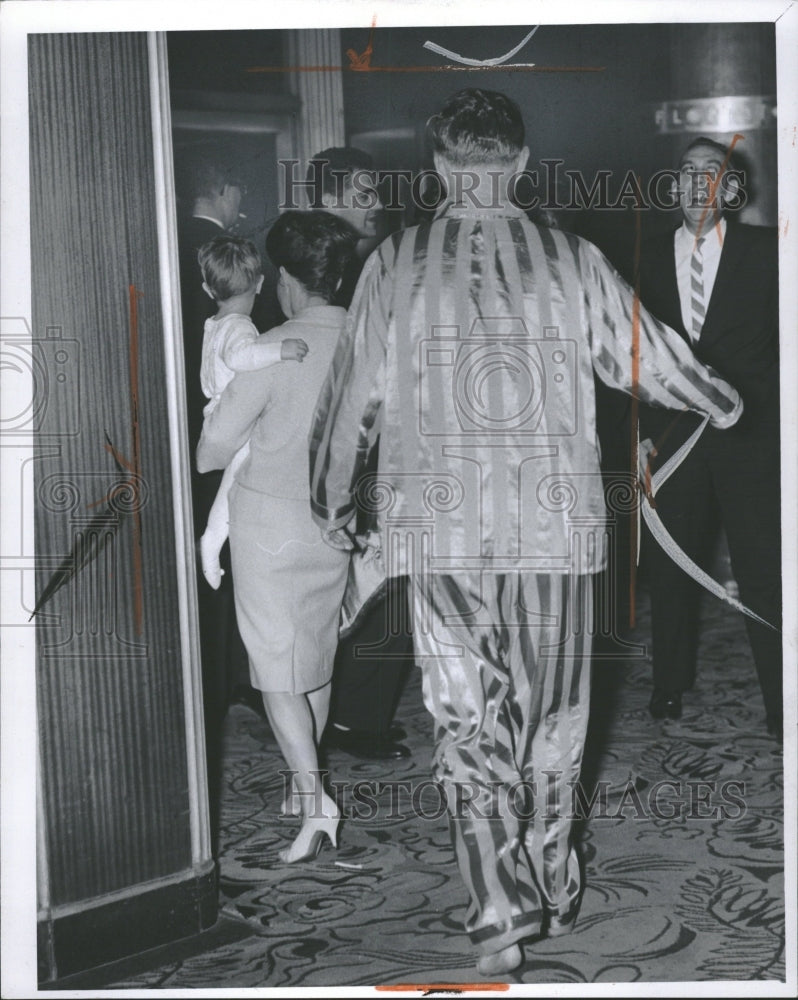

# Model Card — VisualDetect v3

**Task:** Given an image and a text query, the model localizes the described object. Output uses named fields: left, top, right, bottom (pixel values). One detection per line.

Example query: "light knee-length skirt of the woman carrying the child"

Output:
left=230, top=483, right=349, bottom=694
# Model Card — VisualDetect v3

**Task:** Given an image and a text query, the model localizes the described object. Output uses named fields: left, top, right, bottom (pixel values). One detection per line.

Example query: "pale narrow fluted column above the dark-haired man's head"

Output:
left=288, top=28, right=344, bottom=169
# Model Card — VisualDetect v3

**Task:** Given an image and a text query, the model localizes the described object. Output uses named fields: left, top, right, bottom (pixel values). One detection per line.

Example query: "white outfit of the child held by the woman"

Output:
left=200, top=313, right=282, bottom=589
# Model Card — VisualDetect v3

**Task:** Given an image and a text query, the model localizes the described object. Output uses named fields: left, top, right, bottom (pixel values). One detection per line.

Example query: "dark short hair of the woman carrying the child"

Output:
left=266, top=211, right=358, bottom=302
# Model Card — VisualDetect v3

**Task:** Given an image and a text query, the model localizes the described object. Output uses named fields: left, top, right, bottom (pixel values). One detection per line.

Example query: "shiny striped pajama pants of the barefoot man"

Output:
left=412, top=571, right=593, bottom=953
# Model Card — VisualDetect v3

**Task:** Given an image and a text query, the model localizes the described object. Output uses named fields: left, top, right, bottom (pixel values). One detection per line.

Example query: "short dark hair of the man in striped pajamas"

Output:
left=427, top=88, right=524, bottom=167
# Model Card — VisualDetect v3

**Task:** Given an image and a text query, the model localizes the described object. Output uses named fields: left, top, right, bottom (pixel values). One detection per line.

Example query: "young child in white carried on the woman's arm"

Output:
left=198, top=236, right=308, bottom=590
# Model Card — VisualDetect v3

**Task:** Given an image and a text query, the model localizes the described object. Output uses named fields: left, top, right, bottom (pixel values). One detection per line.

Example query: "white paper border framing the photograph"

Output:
left=0, top=0, right=798, bottom=997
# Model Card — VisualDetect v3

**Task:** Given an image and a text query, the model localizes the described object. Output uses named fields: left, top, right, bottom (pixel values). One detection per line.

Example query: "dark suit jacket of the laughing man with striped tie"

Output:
left=640, top=221, right=779, bottom=458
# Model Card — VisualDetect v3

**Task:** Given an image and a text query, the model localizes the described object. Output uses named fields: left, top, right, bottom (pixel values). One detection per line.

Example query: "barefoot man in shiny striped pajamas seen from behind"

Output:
left=311, top=90, right=741, bottom=975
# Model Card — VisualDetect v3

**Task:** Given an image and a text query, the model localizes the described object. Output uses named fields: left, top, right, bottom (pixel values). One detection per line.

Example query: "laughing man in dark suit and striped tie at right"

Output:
left=639, top=138, right=782, bottom=737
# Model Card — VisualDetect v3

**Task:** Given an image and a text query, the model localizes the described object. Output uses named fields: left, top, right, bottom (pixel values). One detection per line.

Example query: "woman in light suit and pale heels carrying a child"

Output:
left=197, top=212, right=357, bottom=863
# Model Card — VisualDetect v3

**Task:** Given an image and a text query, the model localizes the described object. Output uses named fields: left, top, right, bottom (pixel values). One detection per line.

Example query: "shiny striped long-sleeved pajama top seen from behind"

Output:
left=309, top=203, right=742, bottom=576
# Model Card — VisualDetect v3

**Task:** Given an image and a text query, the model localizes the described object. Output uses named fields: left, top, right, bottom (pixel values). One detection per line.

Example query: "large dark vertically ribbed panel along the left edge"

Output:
left=30, top=33, right=191, bottom=906
